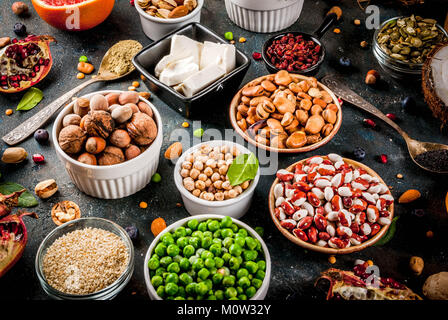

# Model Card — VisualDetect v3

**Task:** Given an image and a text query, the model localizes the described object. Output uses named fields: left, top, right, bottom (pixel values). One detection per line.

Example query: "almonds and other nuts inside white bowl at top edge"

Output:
left=137, top=0, right=198, bottom=19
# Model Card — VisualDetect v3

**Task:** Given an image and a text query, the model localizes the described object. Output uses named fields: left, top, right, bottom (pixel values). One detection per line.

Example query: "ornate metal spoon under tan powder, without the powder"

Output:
left=2, top=40, right=142, bottom=145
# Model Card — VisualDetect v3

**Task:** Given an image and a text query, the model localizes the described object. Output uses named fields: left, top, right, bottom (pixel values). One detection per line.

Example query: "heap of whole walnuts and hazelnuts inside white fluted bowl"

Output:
left=58, top=91, right=158, bottom=166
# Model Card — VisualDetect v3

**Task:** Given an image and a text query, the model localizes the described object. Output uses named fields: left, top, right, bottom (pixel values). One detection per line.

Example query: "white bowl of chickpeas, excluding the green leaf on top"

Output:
left=174, top=140, right=260, bottom=219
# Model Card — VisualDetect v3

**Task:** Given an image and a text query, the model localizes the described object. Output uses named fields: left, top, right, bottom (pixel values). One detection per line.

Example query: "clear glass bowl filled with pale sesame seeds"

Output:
left=35, top=217, right=134, bottom=300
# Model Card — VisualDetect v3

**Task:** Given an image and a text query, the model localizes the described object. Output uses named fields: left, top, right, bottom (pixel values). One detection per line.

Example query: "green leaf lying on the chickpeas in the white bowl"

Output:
left=227, top=153, right=258, bottom=186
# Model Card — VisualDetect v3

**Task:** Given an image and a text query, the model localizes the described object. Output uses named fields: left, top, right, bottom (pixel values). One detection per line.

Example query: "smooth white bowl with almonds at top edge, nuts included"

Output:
left=135, top=0, right=204, bottom=41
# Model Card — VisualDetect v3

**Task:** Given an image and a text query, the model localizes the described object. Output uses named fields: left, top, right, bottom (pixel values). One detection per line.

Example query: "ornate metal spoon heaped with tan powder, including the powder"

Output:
left=2, top=40, right=143, bottom=145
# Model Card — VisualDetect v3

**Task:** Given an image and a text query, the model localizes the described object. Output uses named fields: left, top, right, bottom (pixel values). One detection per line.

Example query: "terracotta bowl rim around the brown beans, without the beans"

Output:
left=229, top=73, right=342, bottom=153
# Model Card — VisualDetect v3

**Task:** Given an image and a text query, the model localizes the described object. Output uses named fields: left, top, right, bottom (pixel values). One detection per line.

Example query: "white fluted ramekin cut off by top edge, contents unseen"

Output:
left=225, top=0, right=304, bottom=33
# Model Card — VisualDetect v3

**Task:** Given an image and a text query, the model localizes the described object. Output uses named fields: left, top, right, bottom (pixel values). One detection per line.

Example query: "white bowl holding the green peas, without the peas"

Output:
left=143, top=214, right=271, bottom=300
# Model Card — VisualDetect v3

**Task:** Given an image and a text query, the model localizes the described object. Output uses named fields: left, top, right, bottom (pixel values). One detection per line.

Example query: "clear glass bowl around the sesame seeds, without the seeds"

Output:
left=35, top=217, right=134, bottom=300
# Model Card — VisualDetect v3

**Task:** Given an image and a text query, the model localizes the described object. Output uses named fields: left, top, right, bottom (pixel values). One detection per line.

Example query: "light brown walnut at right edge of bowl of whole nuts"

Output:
left=126, top=112, right=157, bottom=146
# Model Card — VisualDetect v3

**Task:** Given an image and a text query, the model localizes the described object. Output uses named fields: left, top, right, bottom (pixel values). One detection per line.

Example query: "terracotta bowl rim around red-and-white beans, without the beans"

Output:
left=269, top=156, right=394, bottom=255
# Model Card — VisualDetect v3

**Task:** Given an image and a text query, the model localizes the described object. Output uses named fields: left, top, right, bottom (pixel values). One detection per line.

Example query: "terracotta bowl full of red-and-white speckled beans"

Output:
left=269, top=153, right=394, bottom=254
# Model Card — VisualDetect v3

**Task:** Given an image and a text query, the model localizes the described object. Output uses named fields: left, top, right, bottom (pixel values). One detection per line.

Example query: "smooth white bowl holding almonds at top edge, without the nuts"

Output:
left=135, top=0, right=204, bottom=41
